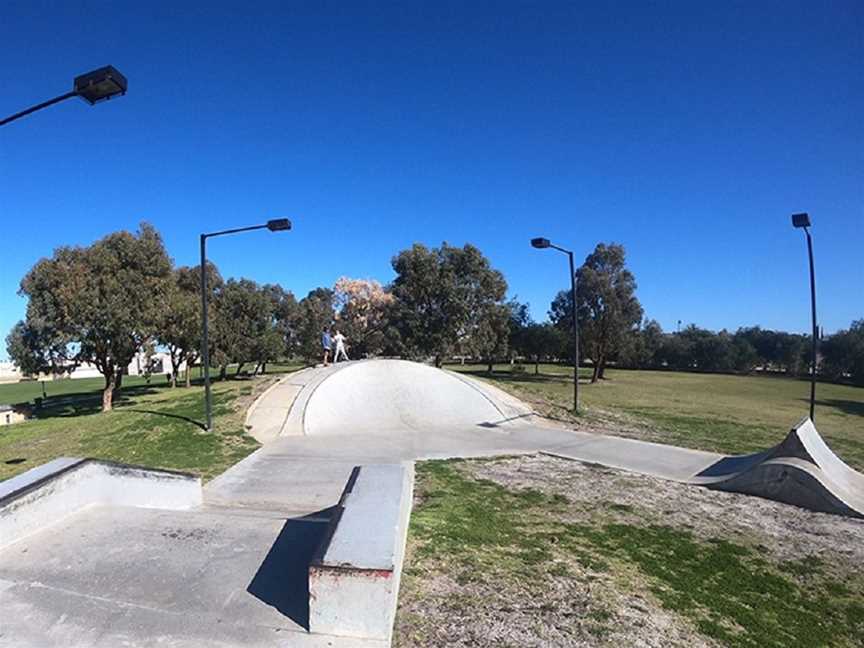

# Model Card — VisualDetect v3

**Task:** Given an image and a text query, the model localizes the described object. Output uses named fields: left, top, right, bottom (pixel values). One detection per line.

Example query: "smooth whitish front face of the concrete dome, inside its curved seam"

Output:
left=303, top=360, right=530, bottom=435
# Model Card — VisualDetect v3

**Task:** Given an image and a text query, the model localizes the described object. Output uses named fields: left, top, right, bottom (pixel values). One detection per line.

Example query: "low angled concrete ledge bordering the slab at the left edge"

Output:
left=0, top=457, right=202, bottom=549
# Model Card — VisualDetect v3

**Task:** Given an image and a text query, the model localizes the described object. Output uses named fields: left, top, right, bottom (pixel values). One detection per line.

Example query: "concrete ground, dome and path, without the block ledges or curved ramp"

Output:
left=0, top=361, right=719, bottom=648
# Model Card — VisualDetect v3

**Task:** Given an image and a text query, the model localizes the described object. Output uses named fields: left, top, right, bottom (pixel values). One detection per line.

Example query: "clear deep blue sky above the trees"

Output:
left=0, top=0, right=864, bottom=356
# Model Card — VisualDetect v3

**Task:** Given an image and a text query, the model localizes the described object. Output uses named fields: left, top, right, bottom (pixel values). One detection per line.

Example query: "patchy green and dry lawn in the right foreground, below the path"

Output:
left=394, top=456, right=864, bottom=648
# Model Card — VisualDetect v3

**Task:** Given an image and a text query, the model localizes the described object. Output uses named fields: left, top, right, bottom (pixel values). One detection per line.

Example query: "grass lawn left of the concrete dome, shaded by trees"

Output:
left=0, top=366, right=298, bottom=480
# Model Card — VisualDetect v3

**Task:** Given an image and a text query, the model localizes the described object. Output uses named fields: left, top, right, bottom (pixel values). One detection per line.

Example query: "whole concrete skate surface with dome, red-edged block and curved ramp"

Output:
left=0, top=360, right=864, bottom=647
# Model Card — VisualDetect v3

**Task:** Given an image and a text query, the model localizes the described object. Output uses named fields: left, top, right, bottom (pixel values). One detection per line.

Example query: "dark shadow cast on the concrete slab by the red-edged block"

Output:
left=246, top=508, right=333, bottom=630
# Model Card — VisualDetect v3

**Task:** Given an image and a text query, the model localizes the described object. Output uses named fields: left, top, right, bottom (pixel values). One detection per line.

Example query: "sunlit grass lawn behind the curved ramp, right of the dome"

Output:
left=448, top=365, right=864, bottom=470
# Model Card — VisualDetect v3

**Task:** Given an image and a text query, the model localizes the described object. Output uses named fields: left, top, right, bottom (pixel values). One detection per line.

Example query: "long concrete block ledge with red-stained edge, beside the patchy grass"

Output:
left=309, top=463, right=414, bottom=645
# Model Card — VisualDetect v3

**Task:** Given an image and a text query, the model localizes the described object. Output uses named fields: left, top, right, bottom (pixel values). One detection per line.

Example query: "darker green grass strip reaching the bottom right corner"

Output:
left=566, top=523, right=864, bottom=648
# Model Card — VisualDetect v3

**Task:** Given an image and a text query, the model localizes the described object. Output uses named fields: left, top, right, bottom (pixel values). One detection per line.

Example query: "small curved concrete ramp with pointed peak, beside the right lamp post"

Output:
left=692, top=418, right=864, bottom=518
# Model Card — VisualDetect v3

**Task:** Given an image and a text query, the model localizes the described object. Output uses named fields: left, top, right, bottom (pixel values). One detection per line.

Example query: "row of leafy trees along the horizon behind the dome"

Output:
left=7, top=223, right=864, bottom=410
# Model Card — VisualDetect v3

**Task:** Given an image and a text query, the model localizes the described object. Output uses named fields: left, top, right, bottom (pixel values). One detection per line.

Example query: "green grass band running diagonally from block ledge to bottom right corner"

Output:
left=406, top=461, right=864, bottom=648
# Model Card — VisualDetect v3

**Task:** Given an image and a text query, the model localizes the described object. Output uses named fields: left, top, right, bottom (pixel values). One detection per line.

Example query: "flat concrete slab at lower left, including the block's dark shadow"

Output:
left=0, top=507, right=384, bottom=646
